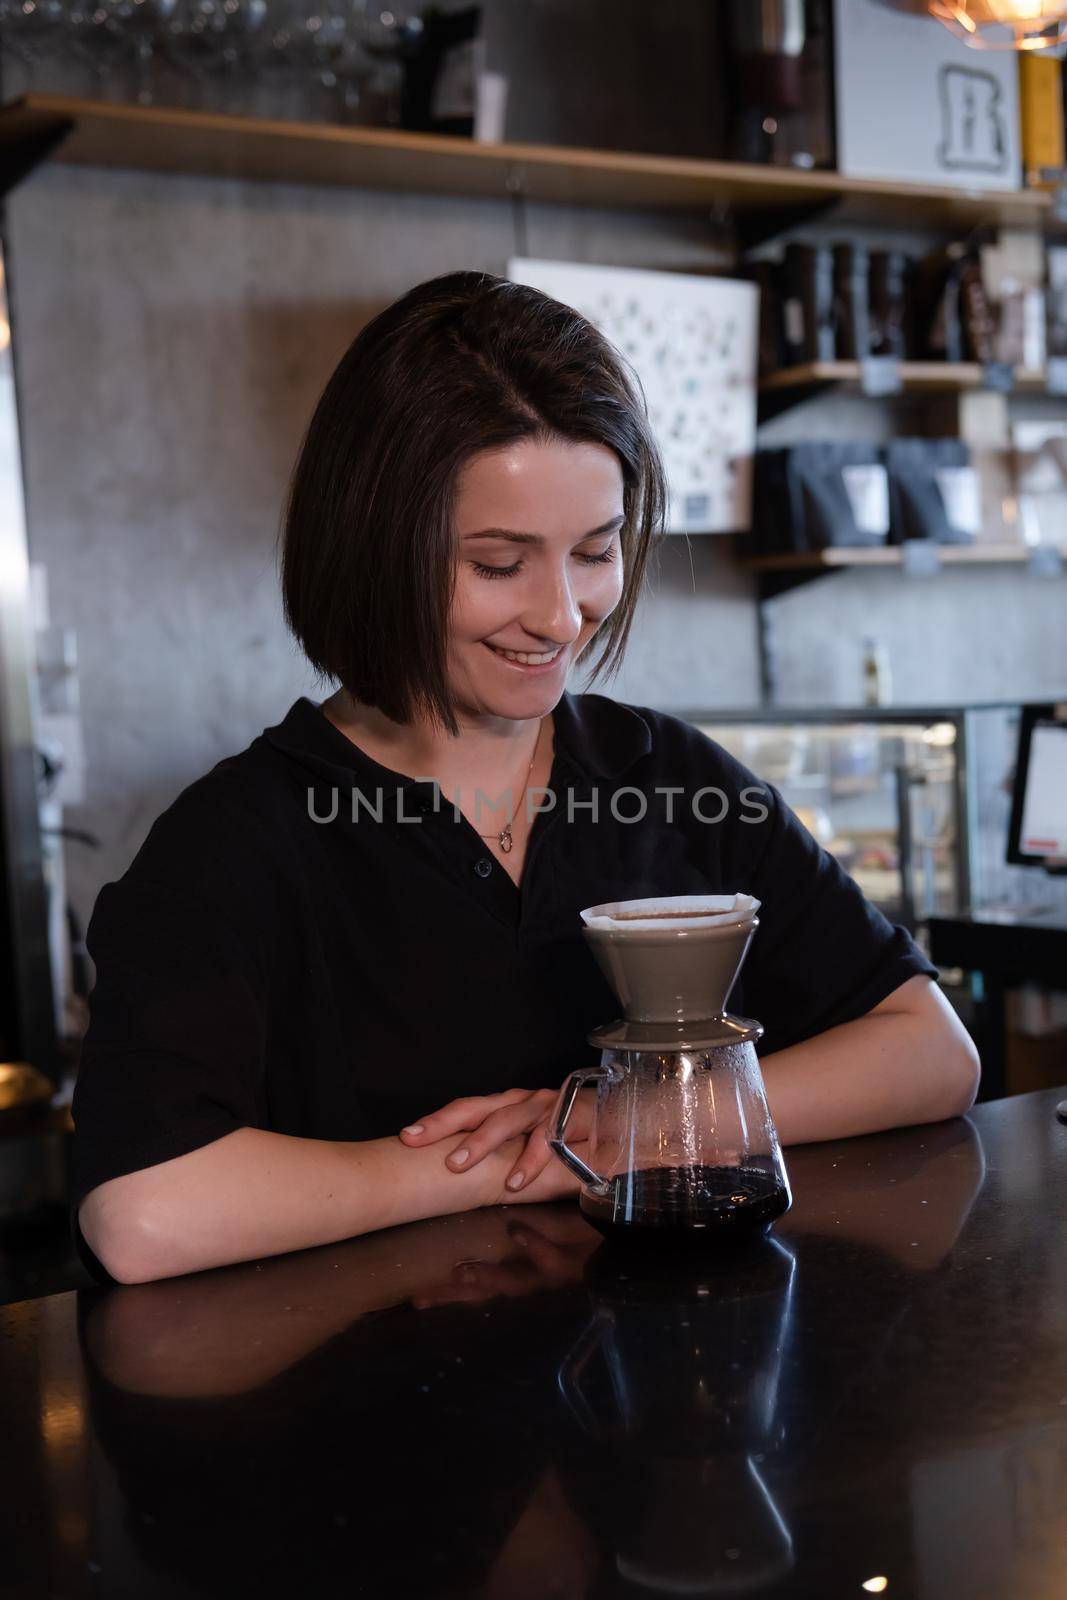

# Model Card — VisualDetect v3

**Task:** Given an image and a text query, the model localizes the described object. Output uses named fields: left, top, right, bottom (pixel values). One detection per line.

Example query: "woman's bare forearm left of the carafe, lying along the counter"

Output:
left=78, top=1128, right=579, bottom=1283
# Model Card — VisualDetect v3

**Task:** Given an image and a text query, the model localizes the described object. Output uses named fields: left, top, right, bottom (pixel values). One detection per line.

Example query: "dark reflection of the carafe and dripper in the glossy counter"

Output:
left=558, top=1238, right=795, bottom=1595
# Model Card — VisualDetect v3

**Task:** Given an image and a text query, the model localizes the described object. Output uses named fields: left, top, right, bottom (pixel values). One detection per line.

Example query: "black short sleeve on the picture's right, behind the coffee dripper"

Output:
left=723, top=752, right=937, bottom=1054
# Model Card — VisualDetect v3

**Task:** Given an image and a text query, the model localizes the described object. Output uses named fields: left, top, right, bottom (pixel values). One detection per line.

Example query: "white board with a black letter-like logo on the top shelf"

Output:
left=833, top=0, right=1022, bottom=189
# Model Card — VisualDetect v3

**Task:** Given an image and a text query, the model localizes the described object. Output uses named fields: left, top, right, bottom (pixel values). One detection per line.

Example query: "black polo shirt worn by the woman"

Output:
left=70, top=693, right=936, bottom=1282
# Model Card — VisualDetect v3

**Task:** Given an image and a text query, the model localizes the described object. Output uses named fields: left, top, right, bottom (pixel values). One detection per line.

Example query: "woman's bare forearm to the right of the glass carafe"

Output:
left=760, top=974, right=981, bottom=1144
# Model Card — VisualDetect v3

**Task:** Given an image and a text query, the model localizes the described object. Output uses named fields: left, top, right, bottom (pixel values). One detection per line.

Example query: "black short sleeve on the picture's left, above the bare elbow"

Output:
left=70, top=875, right=266, bottom=1282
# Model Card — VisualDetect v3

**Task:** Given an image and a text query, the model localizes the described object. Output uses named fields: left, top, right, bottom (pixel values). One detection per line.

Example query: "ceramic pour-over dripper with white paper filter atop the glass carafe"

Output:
left=582, top=894, right=763, bottom=1050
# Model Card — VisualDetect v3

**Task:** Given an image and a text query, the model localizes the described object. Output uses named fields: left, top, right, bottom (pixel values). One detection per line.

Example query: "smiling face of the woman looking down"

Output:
left=448, top=438, right=624, bottom=718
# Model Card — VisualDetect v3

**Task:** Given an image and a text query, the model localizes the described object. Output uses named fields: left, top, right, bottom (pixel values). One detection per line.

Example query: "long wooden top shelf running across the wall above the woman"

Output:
left=0, top=94, right=1053, bottom=229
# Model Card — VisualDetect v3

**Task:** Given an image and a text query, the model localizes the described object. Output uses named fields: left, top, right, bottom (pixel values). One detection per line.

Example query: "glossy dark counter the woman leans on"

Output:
left=0, top=1090, right=1067, bottom=1600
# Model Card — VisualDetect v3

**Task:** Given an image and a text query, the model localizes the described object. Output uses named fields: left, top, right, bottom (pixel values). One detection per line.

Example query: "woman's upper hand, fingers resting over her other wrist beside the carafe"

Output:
left=398, top=1090, right=597, bottom=1198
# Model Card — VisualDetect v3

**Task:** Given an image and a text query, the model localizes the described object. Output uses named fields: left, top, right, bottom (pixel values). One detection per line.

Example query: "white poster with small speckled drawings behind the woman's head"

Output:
left=507, top=256, right=760, bottom=533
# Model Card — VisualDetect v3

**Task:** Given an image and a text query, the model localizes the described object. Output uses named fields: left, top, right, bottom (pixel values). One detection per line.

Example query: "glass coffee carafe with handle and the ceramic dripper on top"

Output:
left=549, top=894, right=792, bottom=1248
